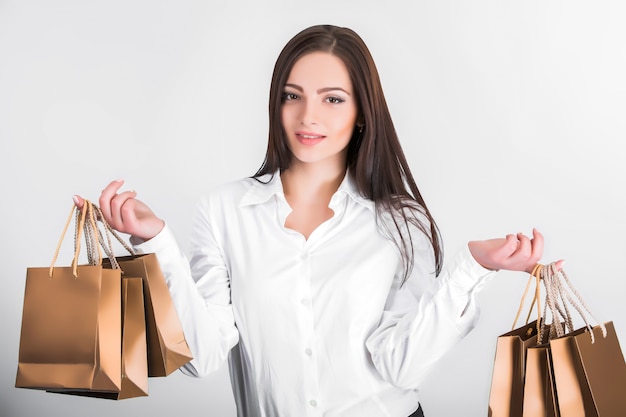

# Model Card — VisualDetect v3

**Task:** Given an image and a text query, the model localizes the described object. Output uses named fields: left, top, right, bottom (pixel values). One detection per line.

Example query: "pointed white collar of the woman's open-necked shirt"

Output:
left=239, top=171, right=374, bottom=211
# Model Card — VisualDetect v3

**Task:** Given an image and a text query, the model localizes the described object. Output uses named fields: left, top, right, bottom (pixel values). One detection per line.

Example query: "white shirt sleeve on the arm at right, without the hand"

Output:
left=366, top=234, right=495, bottom=389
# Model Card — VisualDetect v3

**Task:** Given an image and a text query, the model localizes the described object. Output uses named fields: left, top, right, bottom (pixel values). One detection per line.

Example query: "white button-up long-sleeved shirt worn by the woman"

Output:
left=136, top=174, right=492, bottom=417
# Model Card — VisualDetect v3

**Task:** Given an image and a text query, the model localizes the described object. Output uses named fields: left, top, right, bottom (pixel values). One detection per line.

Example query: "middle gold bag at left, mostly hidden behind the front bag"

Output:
left=48, top=277, right=148, bottom=400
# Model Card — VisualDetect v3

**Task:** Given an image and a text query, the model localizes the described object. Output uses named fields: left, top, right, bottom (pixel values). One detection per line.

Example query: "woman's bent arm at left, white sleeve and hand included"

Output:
left=74, top=181, right=239, bottom=376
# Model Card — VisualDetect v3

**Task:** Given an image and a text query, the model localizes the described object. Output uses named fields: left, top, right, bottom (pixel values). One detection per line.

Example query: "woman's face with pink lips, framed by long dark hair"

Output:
left=281, top=52, right=357, bottom=167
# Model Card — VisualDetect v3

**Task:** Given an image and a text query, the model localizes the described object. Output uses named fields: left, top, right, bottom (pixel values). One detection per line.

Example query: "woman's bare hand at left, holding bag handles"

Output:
left=73, top=180, right=165, bottom=241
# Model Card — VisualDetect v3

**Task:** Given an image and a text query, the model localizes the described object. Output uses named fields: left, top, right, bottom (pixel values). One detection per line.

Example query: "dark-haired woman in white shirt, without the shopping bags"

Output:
left=75, top=26, right=543, bottom=417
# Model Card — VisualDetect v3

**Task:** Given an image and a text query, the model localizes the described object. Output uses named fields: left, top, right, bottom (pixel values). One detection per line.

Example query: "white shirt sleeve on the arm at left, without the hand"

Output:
left=135, top=200, right=239, bottom=377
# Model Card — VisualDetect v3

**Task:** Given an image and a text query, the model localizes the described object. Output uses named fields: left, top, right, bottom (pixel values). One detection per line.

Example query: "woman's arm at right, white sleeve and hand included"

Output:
left=366, top=231, right=543, bottom=389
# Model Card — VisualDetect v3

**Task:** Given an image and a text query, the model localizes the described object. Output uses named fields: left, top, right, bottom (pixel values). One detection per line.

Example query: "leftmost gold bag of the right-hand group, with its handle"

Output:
left=488, top=271, right=542, bottom=417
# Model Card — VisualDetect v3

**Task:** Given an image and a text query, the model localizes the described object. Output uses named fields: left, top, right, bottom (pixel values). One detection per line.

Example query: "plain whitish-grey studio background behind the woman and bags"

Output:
left=0, top=0, right=626, bottom=417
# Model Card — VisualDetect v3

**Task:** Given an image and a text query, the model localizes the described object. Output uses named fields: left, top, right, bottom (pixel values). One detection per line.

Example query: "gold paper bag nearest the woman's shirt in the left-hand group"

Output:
left=96, top=204, right=193, bottom=377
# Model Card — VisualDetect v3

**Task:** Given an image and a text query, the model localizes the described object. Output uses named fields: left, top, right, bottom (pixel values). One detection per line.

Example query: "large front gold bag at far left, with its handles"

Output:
left=15, top=200, right=122, bottom=391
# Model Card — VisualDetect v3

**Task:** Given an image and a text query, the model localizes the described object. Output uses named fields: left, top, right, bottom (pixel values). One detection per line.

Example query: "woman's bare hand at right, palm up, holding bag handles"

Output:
left=468, top=229, right=563, bottom=273
